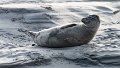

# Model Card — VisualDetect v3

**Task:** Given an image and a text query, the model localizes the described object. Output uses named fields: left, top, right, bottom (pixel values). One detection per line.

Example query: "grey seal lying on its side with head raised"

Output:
left=21, top=15, right=100, bottom=47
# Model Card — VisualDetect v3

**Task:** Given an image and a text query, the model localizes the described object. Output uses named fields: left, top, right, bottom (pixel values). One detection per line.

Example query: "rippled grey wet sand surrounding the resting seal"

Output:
left=0, top=2, right=120, bottom=68
